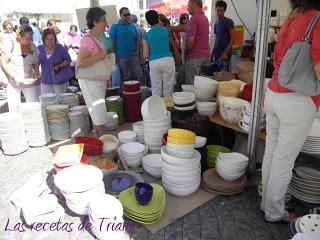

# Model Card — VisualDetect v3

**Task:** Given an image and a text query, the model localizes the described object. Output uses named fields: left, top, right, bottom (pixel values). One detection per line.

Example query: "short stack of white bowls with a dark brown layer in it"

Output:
left=172, top=92, right=196, bottom=111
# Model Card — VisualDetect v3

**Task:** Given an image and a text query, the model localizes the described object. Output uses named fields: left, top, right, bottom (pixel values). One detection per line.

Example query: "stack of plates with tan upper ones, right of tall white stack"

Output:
left=46, top=105, right=70, bottom=140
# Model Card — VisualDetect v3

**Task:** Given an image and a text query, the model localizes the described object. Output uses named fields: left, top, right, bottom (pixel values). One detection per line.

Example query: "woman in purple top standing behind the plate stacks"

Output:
left=38, top=28, right=73, bottom=94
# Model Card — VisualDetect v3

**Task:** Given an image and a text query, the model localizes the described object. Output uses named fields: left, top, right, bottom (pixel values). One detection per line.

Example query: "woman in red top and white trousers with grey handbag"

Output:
left=261, top=0, right=320, bottom=222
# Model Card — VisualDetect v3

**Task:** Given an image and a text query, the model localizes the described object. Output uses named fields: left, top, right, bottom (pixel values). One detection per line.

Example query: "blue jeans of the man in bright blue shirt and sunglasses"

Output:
left=119, top=56, right=146, bottom=86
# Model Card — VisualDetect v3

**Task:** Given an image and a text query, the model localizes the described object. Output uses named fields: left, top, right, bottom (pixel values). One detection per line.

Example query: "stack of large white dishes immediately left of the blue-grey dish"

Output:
left=54, top=164, right=105, bottom=215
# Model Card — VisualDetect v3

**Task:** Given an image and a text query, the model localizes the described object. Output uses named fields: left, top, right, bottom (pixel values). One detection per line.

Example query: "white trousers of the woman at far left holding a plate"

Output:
left=7, top=83, right=39, bottom=112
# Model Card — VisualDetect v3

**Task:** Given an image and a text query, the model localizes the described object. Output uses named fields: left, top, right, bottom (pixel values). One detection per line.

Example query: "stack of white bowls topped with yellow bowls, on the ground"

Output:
left=161, top=129, right=201, bottom=197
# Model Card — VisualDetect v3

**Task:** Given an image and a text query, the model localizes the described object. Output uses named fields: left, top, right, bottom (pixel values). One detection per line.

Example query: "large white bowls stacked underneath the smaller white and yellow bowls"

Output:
left=161, top=147, right=201, bottom=197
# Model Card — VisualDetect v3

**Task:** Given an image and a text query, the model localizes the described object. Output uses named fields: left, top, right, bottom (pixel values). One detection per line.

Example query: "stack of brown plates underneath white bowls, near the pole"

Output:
left=202, top=168, right=247, bottom=195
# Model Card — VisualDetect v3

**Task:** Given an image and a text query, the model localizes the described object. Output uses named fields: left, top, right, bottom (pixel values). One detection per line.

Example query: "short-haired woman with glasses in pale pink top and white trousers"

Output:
left=77, top=7, right=109, bottom=136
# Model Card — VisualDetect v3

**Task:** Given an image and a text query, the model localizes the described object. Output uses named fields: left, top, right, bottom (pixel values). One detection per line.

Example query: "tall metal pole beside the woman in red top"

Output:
left=248, top=0, right=270, bottom=173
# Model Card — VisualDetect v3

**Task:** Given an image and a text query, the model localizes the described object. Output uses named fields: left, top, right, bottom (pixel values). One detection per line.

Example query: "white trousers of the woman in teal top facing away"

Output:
left=149, top=57, right=175, bottom=97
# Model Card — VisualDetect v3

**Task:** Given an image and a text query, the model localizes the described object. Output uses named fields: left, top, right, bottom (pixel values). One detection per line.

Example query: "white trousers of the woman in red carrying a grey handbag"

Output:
left=261, top=90, right=317, bottom=221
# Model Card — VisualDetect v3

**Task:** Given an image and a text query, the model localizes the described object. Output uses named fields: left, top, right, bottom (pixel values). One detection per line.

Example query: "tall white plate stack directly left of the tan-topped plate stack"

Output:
left=20, top=103, right=51, bottom=147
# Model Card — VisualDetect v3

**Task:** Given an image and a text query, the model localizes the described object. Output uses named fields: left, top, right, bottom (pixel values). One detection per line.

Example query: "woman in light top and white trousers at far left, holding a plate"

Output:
left=0, top=25, right=39, bottom=111
